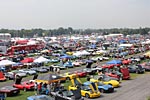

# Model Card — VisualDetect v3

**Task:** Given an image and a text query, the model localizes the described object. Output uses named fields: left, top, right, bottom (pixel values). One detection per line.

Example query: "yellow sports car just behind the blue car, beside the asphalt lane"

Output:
left=90, top=76, right=120, bottom=87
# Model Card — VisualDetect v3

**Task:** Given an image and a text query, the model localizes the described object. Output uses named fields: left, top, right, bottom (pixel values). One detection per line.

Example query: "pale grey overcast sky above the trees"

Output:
left=0, top=0, right=150, bottom=29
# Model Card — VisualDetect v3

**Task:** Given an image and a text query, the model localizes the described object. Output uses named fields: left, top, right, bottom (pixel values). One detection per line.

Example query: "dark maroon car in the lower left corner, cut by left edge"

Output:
left=0, top=86, right=20, bottom=97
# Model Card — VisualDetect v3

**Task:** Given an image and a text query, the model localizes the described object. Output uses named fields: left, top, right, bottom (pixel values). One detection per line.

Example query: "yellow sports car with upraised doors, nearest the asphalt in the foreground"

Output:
left=69, top=78, right=100, bottom=98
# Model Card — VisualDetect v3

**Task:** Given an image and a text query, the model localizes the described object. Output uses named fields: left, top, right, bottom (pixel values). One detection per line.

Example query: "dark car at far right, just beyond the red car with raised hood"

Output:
left=128, top=65, right=145, bottom=74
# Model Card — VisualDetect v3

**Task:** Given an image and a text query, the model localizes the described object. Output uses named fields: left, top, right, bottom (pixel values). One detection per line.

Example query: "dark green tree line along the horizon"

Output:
left=0, top=27, right=150, bottom=37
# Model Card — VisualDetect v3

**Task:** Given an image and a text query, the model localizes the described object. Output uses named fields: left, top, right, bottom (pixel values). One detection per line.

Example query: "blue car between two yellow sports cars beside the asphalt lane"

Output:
left=97, top=82, right=114, bottom=93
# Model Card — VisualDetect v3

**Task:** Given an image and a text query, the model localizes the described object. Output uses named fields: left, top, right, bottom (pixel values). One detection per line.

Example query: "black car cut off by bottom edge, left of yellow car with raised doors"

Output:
left=52, top=89, right=84, bottom=100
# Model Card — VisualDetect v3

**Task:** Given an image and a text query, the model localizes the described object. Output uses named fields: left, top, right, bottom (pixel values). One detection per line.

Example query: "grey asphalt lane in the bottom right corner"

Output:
left=85, top=73, right=150, bottom=100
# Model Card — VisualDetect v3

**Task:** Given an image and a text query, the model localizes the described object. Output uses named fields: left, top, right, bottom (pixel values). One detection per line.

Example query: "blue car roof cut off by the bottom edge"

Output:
left=27, top=95, right=55, bottom=100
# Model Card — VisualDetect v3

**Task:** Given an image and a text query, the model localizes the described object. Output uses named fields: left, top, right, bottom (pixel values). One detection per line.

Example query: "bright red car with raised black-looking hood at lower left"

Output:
left=13, top=78, right=34, bottom=91
